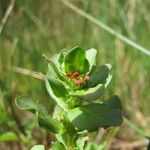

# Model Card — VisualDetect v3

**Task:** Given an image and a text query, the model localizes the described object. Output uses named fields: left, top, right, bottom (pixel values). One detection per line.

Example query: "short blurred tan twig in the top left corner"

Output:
left=0, top=0, right=15, bottom=35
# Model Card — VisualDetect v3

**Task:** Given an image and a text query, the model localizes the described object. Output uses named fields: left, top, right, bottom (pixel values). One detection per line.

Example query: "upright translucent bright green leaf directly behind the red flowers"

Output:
left=64, top=47, right=89, bottom=74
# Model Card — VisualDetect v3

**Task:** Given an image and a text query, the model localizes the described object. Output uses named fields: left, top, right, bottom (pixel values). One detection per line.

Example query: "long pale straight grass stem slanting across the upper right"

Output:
left=60, top=0, right=150, bottom=56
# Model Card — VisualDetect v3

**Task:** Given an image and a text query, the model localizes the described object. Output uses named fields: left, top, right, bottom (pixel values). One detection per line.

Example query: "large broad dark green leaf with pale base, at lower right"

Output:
left=67, top=104, right=123, bottom=131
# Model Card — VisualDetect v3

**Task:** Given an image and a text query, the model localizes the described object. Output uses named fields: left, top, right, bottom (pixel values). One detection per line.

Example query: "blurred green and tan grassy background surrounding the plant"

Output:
left=0, top=0, right=150, bottom=150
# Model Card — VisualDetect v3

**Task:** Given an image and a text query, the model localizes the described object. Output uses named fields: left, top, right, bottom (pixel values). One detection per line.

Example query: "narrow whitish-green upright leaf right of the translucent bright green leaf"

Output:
left=86, top=48, right=97, bottom=75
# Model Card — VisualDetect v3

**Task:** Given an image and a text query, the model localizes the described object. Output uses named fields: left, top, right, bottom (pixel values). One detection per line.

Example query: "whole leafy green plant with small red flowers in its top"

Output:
left=16, top=47, right=123, bottom=150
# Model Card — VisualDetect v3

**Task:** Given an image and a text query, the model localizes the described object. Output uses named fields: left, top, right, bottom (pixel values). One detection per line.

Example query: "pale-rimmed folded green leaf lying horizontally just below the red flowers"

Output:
left=70, top=84, right=105, bottom=101
